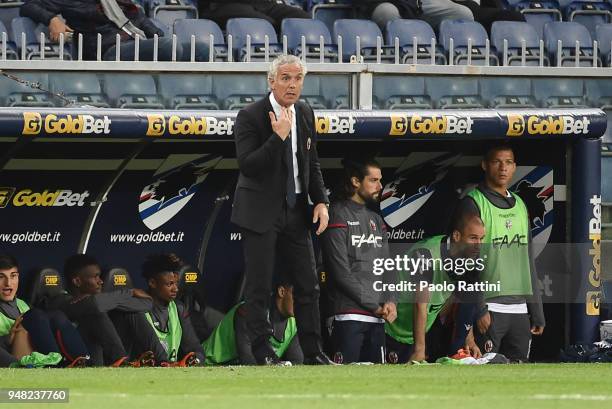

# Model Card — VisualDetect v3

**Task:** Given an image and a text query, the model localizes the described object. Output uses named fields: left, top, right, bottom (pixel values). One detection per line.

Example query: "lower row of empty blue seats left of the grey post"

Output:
left=0, top=73, right=349, bottom=110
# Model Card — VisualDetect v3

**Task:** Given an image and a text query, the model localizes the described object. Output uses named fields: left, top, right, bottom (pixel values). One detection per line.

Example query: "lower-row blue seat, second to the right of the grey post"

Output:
left=425, top=77, right=483, bottom=109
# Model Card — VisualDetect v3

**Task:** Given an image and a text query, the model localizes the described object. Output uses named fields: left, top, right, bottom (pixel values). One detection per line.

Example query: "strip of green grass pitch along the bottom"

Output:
left=0, top=364, right=612, bottom=409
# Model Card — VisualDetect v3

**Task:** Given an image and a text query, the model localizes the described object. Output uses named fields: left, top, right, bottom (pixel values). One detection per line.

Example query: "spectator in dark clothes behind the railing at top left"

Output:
left=20, top=0, right=186, bottom=61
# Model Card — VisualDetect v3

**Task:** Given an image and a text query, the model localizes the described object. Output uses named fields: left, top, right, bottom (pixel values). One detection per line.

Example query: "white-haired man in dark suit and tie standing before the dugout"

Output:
left=232, top=55, right=332, bottom=365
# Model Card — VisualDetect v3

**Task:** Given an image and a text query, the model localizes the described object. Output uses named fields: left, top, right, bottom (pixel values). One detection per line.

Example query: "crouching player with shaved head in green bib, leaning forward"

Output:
left=385, top=214, right=485, bottom=363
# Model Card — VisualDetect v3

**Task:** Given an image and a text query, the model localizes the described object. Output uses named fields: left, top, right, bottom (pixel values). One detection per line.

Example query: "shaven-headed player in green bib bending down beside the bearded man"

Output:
left=385, top=214, right=485, bottom=363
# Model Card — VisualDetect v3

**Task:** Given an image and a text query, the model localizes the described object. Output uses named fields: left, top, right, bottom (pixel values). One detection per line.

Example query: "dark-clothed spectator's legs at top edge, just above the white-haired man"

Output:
left=198, top=0, right=310, bottom=31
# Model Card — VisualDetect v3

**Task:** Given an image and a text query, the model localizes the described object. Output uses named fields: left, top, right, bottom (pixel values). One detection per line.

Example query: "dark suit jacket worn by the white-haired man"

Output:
left=232, top=95, right=329, bottom=233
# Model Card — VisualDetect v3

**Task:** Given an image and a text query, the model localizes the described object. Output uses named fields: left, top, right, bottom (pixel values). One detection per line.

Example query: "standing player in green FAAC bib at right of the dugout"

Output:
left=459, top=146, right=545, bottom=361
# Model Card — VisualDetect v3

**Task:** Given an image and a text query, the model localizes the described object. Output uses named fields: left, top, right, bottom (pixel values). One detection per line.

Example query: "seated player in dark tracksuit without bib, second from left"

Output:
left=48, top=254, right=152, bottom=367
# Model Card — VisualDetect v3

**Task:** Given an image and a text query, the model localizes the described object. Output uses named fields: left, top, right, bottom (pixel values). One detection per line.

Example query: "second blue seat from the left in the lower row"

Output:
left=49, top=72, right=110, bottom=108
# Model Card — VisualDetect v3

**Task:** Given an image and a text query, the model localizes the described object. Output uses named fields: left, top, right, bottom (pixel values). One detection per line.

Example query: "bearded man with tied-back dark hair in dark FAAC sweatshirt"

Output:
left=321, top=157, right=396, bottom=363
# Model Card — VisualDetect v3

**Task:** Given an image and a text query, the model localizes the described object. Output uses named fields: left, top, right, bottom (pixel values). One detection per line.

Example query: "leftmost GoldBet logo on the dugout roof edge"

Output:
left=22, top=112, right=111, bottom=135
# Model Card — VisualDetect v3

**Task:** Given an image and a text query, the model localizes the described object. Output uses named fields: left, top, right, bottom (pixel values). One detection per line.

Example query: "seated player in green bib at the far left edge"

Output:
left=0, top=254, right=89, bottom=367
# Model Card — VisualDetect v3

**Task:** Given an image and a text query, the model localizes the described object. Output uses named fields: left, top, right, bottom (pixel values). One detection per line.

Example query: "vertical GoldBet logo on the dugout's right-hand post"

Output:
left=586, top=195, right=601, bottom=315
